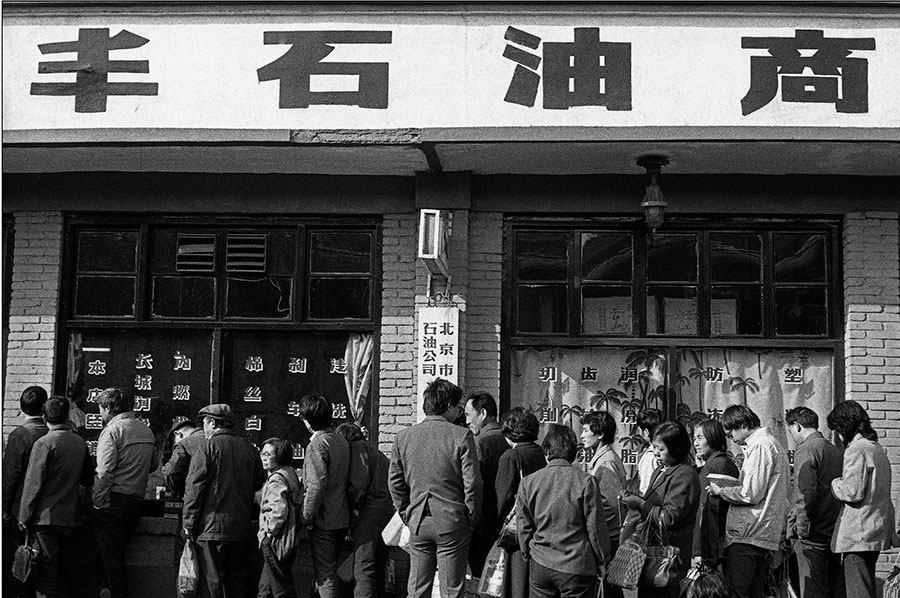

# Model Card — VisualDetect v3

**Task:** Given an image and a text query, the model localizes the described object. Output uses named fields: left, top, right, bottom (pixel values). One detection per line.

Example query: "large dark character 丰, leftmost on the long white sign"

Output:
left=31, top=28, right=159, bottom=112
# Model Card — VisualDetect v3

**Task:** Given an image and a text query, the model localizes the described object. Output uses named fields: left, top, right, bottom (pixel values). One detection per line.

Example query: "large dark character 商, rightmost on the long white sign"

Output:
left=741, top=29, right=875, bottom=116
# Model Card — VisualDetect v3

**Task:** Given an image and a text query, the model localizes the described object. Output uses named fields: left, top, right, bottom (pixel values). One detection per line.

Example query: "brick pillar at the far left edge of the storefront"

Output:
left=3, top=212, right=62, bottom=440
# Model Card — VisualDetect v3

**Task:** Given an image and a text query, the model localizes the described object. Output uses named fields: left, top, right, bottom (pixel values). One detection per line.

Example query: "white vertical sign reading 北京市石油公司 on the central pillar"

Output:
left=416, top=307, right=459, bottom=421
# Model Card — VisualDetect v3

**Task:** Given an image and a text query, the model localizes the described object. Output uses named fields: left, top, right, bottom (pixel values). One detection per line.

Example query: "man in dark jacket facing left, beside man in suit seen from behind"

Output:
left=465, top=392, right=509, bottom=577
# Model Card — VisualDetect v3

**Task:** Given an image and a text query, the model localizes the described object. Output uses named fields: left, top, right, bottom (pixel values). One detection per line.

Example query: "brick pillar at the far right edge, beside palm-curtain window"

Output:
left=843, top=212, right=900, bottom=575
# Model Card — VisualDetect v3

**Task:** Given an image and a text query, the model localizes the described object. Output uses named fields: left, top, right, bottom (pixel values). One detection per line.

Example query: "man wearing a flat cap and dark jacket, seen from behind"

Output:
left=182, top=403, right=266, bottom=598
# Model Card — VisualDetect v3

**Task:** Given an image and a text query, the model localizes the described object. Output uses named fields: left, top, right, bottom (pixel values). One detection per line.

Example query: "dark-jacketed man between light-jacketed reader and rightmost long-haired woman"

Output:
left=785, top=407, right=845, bottom=598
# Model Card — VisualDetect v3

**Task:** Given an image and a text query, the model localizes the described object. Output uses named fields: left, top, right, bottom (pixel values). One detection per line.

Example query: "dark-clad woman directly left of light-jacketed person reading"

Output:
left=691, top=419, right=741, bottom=569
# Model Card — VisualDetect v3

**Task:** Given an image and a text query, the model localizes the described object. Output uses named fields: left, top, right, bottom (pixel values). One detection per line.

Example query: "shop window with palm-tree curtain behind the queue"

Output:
left=504, top=218, right=840, bottom=474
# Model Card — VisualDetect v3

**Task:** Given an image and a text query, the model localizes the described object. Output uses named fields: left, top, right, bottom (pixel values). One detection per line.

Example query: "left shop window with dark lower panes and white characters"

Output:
left=61, top=217, right=380, bottom=458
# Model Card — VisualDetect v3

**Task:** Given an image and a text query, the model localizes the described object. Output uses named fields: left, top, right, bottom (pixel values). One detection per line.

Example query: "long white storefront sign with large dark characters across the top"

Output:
left=3, top=13, right=900, bottom=130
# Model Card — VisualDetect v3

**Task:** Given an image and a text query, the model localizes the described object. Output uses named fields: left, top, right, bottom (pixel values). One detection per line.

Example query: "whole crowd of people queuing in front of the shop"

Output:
left=3, top=379, right=900, bottom=598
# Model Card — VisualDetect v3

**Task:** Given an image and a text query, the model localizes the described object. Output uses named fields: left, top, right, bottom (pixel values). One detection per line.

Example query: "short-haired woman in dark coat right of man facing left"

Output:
left=485, top=407, right=547, bottom=598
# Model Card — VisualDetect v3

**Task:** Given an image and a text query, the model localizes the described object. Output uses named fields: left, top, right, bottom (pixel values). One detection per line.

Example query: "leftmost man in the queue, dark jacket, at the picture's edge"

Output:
left=3, top=386, right=47, bottom=598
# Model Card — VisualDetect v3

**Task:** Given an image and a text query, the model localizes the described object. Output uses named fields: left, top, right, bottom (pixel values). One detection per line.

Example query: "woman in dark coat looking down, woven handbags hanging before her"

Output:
left=622, top=422, right=700, bottom=598
